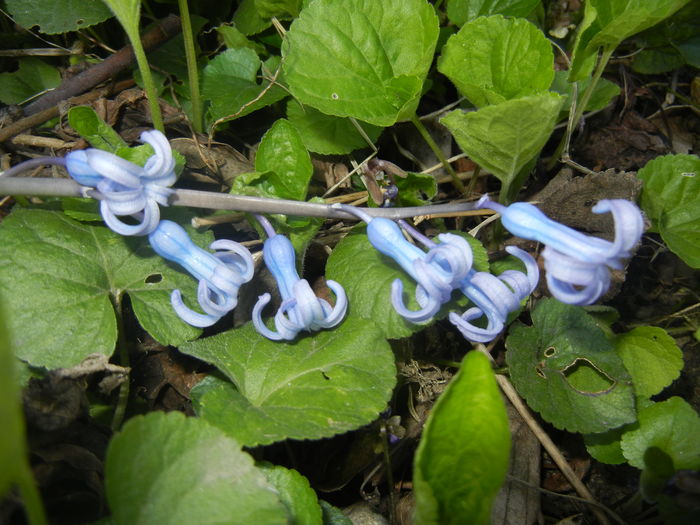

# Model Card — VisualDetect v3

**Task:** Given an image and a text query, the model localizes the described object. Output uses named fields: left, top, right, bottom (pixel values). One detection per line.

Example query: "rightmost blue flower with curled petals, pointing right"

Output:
left=477, top=195, right=644, bottom=305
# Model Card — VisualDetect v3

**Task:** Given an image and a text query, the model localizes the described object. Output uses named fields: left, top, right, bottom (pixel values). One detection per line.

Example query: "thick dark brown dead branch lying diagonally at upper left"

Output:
left=24, top=14, right=182, bottom=116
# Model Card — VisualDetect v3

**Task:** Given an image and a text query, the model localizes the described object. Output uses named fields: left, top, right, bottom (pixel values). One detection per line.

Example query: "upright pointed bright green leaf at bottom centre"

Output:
left=413, top=351, right=510, bottom=525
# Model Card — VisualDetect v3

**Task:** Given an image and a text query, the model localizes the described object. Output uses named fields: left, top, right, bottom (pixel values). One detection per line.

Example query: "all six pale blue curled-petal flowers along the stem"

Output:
left=13, top=131, right=644, bottom=342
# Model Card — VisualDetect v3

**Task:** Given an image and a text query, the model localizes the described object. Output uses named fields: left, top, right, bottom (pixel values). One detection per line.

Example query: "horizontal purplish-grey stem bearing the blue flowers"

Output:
left=0, top=177, right=482, bottom=220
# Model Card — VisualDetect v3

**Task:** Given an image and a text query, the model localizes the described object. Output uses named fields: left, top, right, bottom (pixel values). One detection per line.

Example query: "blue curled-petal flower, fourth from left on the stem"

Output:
left=334, top=204, right=472, bottom=323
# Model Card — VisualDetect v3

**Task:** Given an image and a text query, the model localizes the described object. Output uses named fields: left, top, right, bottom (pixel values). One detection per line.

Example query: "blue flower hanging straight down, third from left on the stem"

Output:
left=253, top=216, right=348, bottom=341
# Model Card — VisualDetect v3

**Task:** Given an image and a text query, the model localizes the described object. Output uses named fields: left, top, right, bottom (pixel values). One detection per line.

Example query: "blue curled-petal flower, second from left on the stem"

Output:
left=148, top=220, right=254, bottom=327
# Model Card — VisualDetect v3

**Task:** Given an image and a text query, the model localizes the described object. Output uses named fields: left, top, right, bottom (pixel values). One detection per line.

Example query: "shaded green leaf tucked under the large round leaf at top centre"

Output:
left=287, top=99, right=383, bottom=155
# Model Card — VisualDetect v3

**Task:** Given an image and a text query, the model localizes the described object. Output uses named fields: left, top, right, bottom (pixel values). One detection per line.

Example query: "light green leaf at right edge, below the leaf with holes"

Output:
left=622, top=397, right=700, bottom=470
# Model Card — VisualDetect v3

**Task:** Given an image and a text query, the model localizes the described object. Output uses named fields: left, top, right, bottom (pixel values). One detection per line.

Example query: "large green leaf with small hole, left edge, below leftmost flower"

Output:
left=0, top=209, right=205, bottom=369
